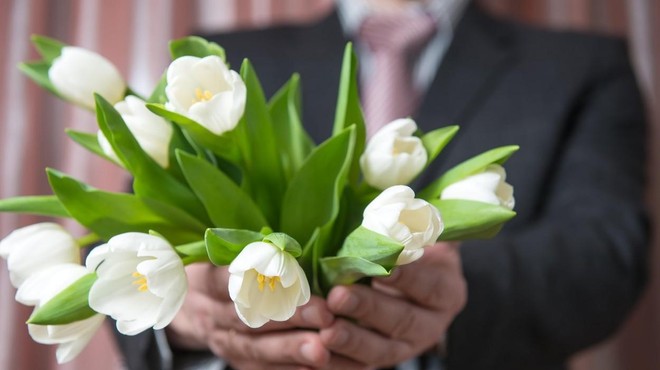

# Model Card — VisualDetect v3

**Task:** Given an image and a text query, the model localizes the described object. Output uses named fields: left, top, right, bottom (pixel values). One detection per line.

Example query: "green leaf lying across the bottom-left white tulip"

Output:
left=27, top=273, right=96, bottom=325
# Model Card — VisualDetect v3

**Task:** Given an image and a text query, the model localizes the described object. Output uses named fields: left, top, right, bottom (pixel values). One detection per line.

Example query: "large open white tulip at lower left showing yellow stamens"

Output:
left=86, top=233, right=188, bottom=335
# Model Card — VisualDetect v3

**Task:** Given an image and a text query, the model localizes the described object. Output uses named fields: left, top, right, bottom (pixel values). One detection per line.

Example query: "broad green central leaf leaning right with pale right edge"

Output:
left=281, top=126, right=355, bottom=246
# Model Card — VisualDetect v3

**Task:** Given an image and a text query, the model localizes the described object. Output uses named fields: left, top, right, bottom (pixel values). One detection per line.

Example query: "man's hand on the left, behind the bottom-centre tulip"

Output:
left=167, top=264, right=333, bottom=370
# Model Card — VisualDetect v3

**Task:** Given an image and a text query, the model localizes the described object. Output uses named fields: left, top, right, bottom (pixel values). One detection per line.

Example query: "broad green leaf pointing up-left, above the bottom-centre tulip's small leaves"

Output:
left=177, top=152, right=268, bottom=230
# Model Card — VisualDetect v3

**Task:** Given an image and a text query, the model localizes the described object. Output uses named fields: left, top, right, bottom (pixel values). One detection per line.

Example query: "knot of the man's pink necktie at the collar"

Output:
left=359, top=13, right=436, bottom=56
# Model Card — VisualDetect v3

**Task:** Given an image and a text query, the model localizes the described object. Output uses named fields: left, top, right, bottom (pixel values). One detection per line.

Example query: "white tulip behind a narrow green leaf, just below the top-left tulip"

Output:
left=97, top=95, right=173, bottom=168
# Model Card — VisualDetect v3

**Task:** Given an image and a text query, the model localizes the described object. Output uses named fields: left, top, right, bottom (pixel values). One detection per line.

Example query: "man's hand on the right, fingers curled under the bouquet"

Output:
left=320, top=243, right=467, bottom=369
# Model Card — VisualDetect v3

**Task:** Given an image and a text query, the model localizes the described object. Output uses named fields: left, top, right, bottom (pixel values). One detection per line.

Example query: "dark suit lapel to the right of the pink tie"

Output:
left=417, top=5, right=514, bottom=132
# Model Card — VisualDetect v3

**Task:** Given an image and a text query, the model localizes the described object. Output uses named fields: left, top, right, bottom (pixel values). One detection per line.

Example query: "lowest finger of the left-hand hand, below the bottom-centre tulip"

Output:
left=209, top=330, right=330, bottom=369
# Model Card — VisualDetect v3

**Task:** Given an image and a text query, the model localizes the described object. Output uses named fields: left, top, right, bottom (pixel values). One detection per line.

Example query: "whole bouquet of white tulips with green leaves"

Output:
left=0, top=37, right=517, bottom=362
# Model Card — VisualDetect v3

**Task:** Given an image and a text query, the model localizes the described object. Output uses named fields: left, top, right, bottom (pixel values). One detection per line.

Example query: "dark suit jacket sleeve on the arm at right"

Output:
left=447, top=40, right=648, bottom=370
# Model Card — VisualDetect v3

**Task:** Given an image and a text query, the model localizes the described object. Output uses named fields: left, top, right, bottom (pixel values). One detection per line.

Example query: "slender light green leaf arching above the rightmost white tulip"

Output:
left=417, top=145, right=520, bottom=201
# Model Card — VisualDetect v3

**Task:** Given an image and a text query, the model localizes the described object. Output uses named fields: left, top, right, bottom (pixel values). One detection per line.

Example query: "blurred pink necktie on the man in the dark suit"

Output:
left=359, top=13, right=436, bottom=136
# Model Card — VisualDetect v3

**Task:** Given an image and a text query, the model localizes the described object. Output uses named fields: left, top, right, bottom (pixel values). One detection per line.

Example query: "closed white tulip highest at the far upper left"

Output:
left=48, top=46, right=126, bottom=110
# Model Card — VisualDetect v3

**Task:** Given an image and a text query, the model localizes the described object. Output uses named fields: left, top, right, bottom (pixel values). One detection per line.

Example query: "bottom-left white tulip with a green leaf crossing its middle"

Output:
left=16, top=263, right=105, bottom=364
